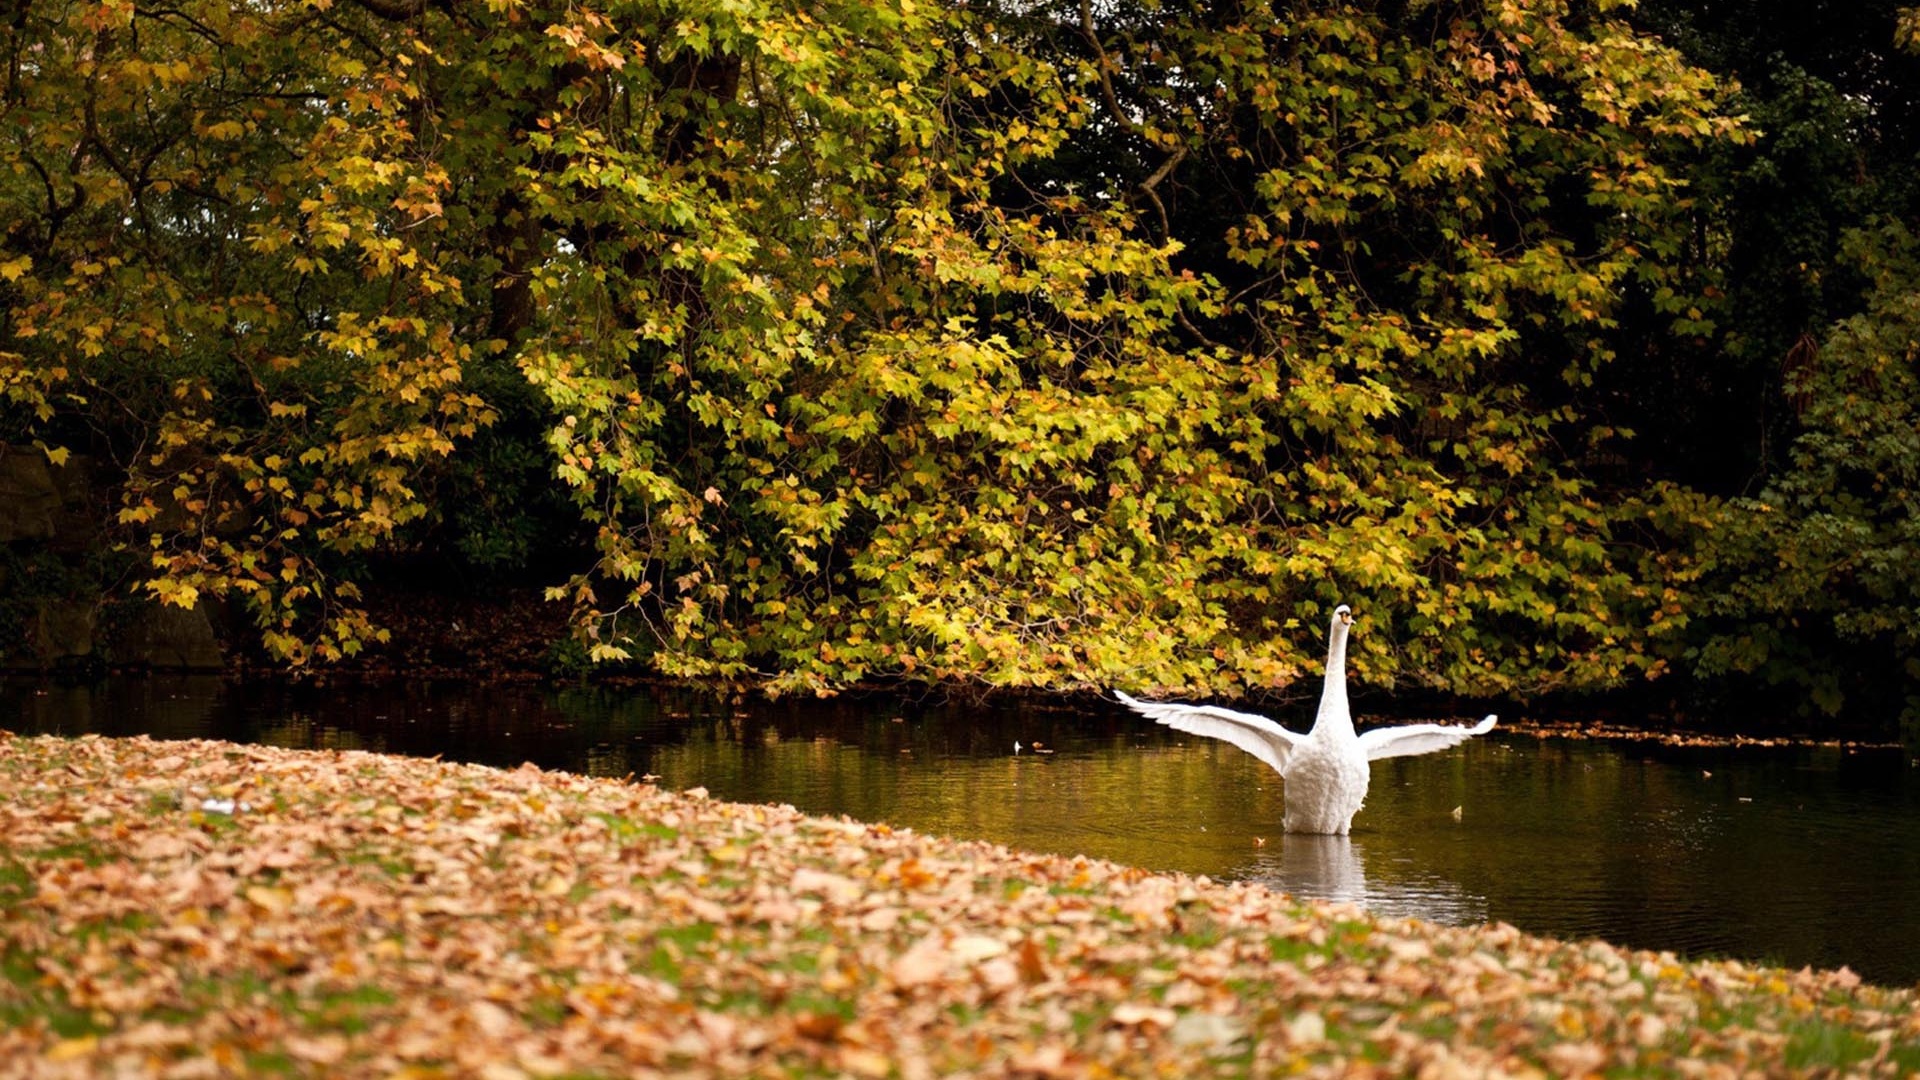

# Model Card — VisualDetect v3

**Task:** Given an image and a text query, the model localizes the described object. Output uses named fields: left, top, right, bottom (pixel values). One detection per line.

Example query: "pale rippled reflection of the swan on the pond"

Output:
left=1235, top=834, right=1488, bottom=926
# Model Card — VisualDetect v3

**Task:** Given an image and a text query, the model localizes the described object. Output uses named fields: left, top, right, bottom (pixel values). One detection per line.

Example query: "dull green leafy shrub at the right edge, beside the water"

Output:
left=1690, top=223, right=1920, bottom=726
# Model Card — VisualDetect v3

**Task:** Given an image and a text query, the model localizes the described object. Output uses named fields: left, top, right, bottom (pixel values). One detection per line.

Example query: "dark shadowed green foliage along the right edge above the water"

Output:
left=1640, top=0, right=1920, bottom=732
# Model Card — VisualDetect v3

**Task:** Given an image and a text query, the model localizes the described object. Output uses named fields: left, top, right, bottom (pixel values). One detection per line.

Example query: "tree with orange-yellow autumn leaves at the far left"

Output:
left=0, top=2, right=492, bottom=663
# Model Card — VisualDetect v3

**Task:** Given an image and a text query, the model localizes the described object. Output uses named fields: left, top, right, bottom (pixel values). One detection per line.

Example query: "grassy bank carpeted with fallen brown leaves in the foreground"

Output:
left=0, top=732, right=1920, bottom=1078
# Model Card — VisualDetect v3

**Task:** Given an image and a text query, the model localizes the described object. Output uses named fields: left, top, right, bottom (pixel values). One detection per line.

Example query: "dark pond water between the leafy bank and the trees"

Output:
left=15, top=676, right=1920, bottom=984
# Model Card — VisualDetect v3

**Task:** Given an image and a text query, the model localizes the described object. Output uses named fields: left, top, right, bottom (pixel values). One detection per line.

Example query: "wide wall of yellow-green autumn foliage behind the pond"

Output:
left=0, top=0, right=1914, bottom=722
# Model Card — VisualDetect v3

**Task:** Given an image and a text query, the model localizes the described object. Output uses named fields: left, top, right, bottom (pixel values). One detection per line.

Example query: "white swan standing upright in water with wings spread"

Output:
left=1116, top=603, right=1498, bottom=836
